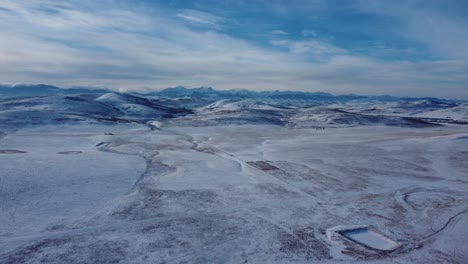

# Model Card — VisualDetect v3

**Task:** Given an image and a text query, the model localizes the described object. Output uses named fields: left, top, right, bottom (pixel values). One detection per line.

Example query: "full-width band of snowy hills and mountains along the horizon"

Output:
left=0, top=85, right=468, bottom=128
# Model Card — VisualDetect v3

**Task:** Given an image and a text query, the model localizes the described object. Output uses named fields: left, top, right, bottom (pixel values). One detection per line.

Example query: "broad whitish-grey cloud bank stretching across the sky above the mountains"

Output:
left=0, top=0, right=468, bottom=99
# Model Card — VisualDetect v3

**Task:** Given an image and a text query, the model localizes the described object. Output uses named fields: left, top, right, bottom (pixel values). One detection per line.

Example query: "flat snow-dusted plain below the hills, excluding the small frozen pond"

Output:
left=0, top=120, right=468, bottom=264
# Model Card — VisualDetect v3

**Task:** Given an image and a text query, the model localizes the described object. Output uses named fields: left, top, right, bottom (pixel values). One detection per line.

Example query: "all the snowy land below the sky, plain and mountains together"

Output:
left=0, top=87, right=468, bottom=264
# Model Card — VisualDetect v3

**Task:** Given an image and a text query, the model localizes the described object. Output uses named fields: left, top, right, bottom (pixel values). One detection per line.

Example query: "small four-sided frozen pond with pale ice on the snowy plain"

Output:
left=340, top=227, right=400, bottom=251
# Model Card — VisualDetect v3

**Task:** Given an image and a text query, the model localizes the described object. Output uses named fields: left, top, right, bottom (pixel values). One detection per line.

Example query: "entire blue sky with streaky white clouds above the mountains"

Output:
left=0, top=0, right=468, bottom=99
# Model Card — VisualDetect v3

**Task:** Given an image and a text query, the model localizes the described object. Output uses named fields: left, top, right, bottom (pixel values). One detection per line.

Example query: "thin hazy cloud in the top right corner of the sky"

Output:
left=355, top=0, right=468, bottom=59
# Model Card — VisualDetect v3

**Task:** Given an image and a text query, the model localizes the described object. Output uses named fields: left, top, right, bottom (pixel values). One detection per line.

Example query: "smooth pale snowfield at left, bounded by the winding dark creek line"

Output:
left=0, top=126, right=145, bottom=252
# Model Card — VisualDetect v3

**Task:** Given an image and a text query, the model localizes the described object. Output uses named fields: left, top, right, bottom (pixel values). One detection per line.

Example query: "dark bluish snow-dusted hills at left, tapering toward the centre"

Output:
left=0, top=93, right=192, bottom=128
